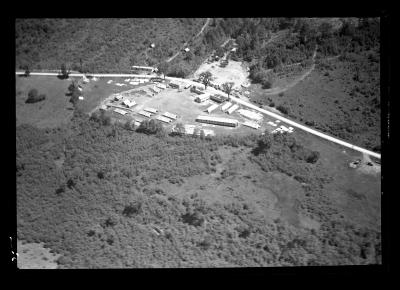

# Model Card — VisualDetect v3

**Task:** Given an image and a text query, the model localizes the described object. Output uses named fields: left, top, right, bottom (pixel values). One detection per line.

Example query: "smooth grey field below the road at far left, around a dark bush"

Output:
left=15, top=76, right=73, bottom=128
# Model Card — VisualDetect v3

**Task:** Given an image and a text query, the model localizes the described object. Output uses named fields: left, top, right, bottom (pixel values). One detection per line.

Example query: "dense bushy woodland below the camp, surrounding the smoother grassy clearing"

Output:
left=16, top=113, right=380, bottom=268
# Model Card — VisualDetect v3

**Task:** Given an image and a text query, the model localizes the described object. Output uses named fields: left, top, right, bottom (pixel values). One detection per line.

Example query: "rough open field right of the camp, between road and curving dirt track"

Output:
left=249, top=59, right=381, bottom=151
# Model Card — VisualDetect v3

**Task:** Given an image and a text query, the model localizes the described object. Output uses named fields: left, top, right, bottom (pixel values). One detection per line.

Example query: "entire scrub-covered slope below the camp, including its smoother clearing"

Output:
left=17, top=114, right=381, bottom=268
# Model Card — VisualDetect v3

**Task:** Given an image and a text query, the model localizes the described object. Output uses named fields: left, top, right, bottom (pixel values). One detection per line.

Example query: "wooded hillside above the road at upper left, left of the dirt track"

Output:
left=15, top=18, right=205, bottom=72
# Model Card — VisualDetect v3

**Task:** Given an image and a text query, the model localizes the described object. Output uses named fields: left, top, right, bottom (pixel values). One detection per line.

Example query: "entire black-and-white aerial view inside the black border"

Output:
left=11, top=17, right=383, bottom=269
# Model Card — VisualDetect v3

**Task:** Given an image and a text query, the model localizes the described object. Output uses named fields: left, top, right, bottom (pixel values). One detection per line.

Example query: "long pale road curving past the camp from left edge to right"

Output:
left=16, top=72, right=381, bottom=159
